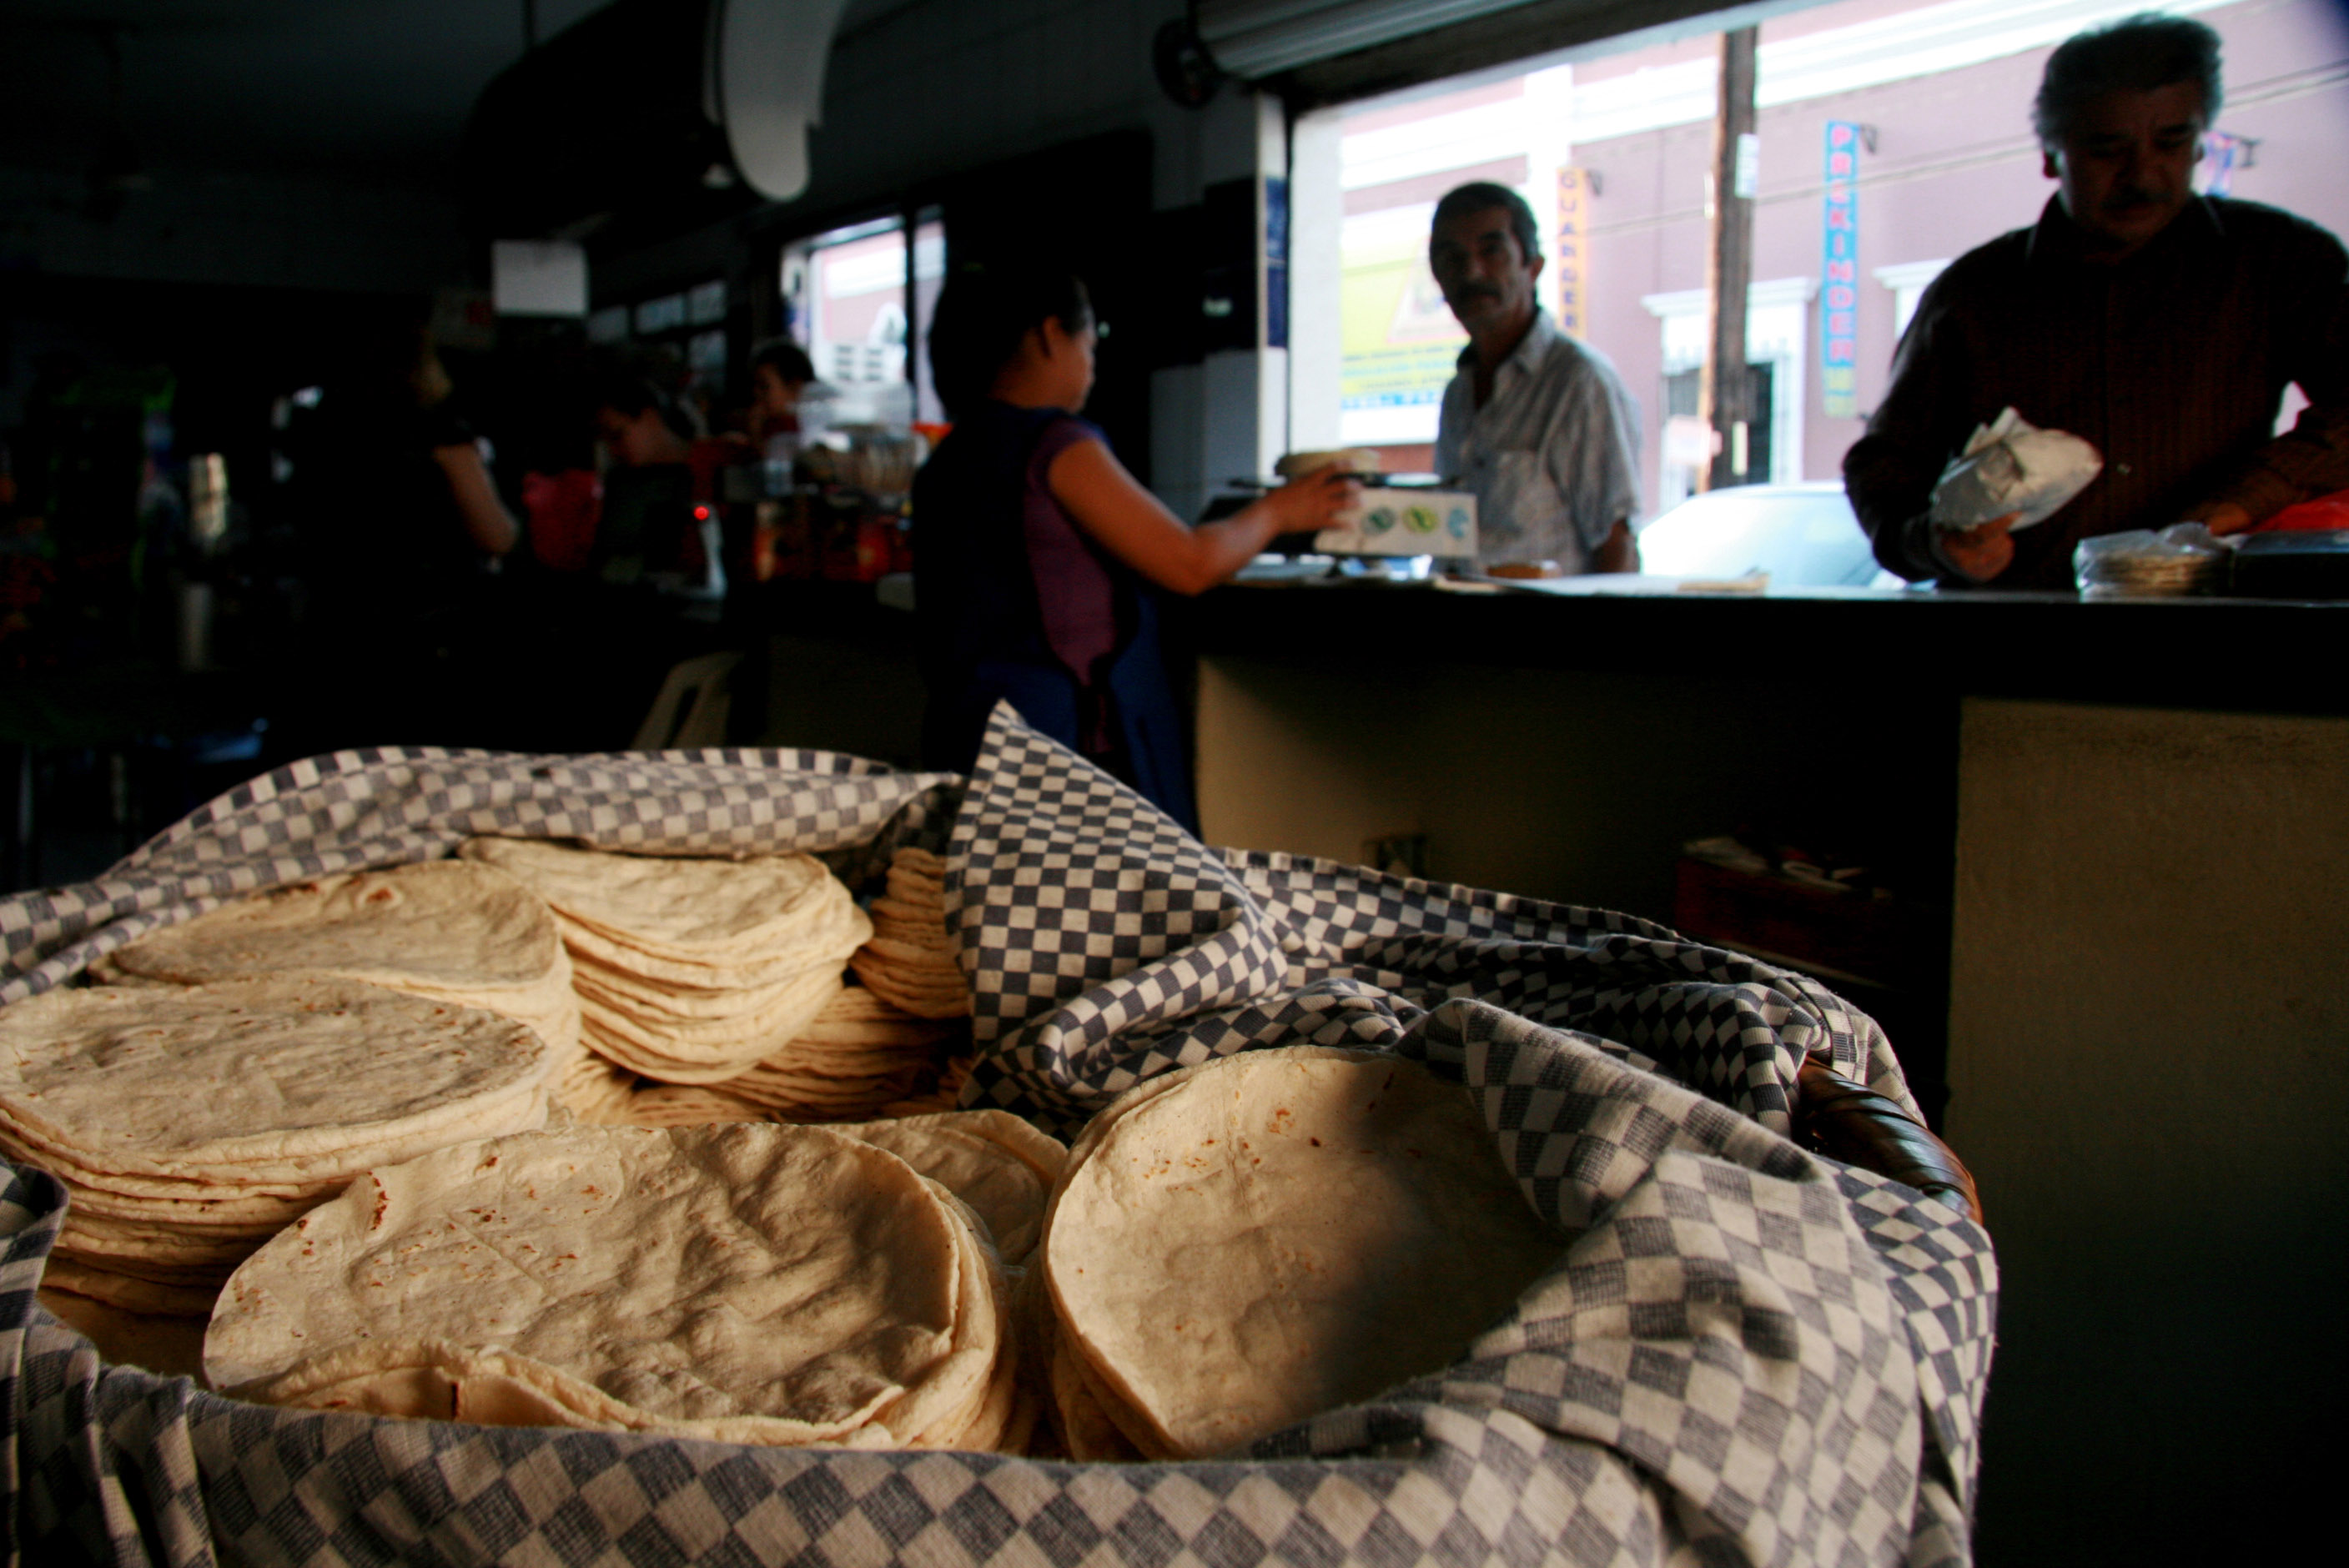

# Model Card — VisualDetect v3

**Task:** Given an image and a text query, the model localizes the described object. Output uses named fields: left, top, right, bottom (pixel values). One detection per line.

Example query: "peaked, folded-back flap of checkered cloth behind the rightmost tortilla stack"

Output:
left=947, top=709, right=1924, bottom=1133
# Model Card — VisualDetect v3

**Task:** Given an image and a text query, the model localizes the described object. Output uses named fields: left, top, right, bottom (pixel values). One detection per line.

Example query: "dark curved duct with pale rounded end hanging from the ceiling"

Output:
left=463, top=0, right=846, bottom=237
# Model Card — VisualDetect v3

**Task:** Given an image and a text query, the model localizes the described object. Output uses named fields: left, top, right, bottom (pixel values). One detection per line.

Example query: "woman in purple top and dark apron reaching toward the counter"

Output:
left=913, top=265, right=1360, bottom=831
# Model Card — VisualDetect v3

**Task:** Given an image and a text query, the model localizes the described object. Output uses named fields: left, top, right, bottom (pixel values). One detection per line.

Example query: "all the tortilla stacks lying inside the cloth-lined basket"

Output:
left=13, top=838, right=1562, bottom=1460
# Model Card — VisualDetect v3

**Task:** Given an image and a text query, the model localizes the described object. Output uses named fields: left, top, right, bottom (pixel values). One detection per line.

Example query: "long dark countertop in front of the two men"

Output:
left=1186, top=577, right=2349, bottom=714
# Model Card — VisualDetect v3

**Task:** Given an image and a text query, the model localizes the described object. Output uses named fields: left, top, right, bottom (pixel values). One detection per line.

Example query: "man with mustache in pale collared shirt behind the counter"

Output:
left=1428, top=181, right=1640, bottom=575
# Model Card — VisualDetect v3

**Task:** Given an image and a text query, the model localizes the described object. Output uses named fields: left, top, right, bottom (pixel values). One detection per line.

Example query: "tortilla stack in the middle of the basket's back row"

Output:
left=463, top=838, right=872, bottom=1084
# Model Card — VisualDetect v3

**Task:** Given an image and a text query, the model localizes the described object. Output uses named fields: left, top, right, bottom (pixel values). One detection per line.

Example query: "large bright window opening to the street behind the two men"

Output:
left=1290, top=0, right=2349, bottom=514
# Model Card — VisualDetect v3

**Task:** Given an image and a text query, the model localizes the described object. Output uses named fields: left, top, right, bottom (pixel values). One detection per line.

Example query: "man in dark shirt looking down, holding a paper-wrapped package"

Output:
left=1844, top=14, right=2349, bottom=589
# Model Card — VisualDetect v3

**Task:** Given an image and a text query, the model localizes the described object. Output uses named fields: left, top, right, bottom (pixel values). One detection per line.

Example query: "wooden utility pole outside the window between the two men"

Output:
left=1696, top=28, right=1762, bottom=490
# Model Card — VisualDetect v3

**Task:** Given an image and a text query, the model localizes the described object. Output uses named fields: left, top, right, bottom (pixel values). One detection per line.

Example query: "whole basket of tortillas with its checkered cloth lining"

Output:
left=0, top=727, right=1997, bottom=1568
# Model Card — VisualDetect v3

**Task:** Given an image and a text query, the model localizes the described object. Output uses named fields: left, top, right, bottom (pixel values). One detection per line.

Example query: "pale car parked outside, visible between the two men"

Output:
left=1640, top=481, right=1903, bottom=587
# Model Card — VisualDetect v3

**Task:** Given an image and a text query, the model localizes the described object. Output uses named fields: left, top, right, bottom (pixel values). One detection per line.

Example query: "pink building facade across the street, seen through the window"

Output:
left=1315, top=0, right=2349, bottom=514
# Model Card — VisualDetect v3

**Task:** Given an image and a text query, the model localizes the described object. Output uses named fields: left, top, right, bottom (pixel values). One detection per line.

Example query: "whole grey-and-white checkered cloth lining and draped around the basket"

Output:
left=0, top=714, right=1997, bottom=1568
